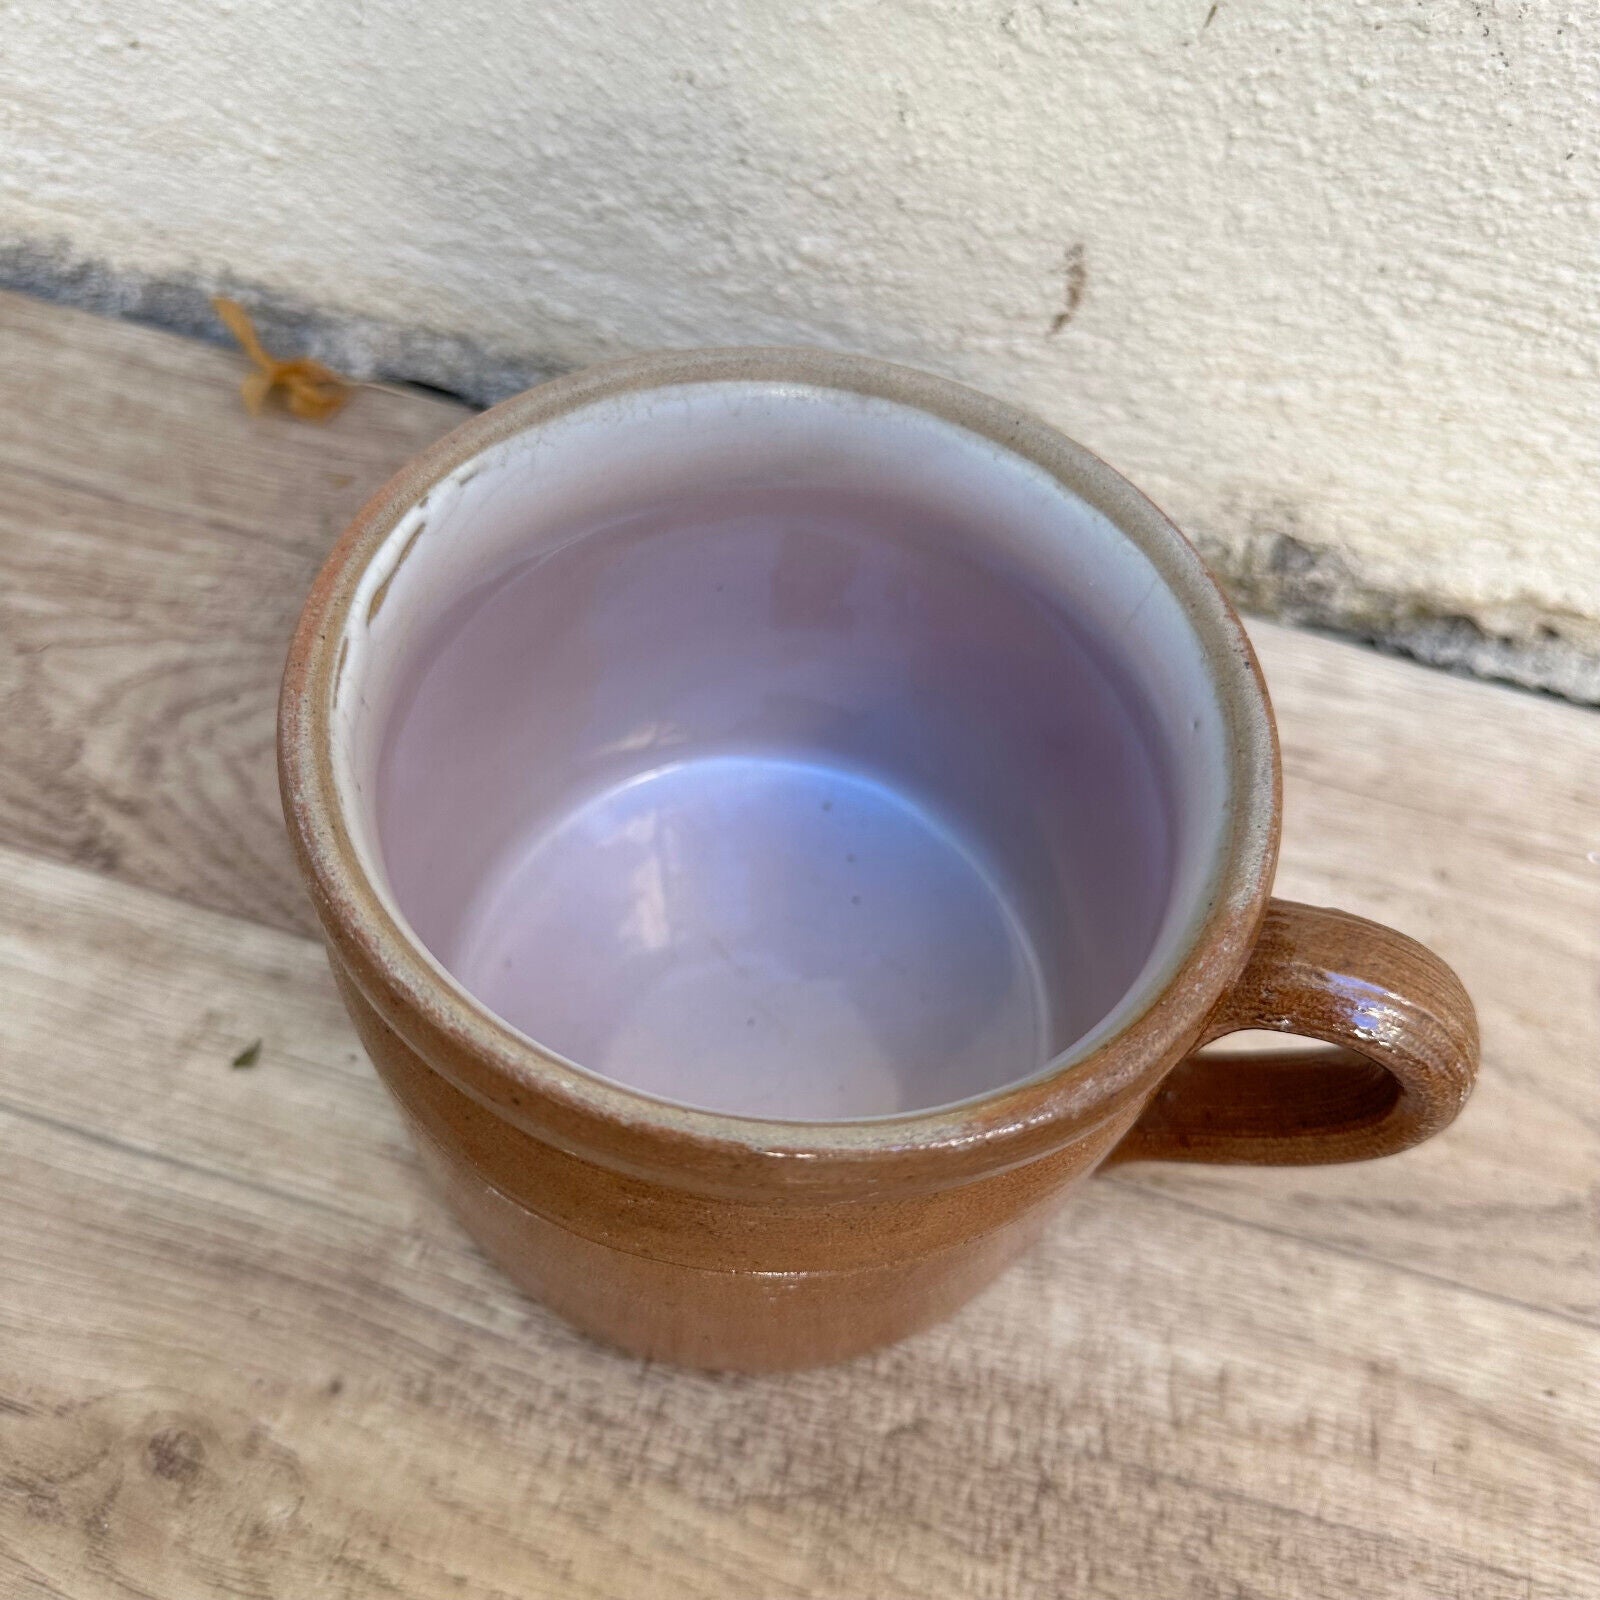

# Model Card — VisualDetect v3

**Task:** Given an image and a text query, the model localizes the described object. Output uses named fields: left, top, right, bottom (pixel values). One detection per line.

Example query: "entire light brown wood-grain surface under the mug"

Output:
left=0, top=296, right=1600, bottom=1600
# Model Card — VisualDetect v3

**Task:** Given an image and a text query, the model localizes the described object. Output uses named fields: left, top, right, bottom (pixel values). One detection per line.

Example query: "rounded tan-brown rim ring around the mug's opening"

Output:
left=278, top=346, right=1282, bottom=1190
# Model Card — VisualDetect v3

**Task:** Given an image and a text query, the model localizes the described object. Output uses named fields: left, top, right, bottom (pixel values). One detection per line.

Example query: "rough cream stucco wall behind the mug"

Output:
left=0, top=0, right=1600, bottom=698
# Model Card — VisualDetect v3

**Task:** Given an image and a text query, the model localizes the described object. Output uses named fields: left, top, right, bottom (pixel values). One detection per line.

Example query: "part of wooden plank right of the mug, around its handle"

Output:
left=1110, top=624, right=1600, bottom=1320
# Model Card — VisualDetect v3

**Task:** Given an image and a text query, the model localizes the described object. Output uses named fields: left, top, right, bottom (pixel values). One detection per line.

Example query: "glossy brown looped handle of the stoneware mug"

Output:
left=1107, top=899, right=1478, bottom=1166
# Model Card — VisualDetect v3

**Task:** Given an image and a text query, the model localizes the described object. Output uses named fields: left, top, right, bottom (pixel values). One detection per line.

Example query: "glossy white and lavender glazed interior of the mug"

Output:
left=334, top=382, right=1227, bottom=1120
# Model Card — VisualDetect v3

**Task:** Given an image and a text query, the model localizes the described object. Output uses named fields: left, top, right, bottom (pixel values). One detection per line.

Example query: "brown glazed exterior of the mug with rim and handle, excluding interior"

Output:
left=278, top=350, right=1477, bottom=1370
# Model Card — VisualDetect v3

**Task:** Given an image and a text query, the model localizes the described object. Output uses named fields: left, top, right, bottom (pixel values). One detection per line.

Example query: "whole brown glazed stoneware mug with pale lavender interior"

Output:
left=278, top=349, right=1477, bottom=1370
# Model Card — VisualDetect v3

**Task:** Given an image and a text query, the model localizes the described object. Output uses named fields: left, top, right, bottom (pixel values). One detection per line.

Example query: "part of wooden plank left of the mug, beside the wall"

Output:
left=0, top=294, right=466, bottom=931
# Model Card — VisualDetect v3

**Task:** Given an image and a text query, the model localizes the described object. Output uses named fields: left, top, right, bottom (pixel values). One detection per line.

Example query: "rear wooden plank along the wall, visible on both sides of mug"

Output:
left=0, top=284, right=1600, bottom=1317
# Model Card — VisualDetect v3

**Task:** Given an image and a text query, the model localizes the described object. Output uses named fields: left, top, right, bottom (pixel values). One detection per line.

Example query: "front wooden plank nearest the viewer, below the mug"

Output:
left=0, top=851, right=1600, bottom=1600
